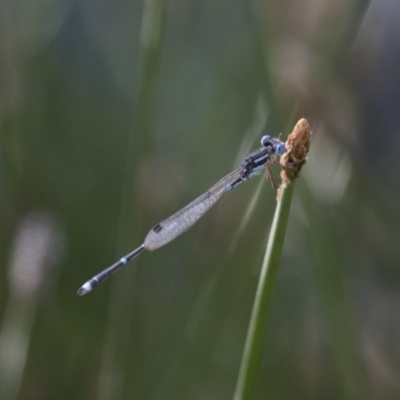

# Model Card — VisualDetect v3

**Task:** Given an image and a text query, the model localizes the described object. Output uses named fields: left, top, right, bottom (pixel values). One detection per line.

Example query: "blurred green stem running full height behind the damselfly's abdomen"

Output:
left=98, top=0, right=165, bottom=400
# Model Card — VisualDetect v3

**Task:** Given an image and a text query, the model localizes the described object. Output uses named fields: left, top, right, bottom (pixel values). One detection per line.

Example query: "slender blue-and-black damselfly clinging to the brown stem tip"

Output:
left=78, top=135, right=286, bottom=296
